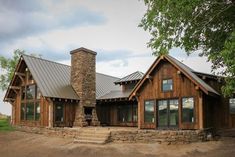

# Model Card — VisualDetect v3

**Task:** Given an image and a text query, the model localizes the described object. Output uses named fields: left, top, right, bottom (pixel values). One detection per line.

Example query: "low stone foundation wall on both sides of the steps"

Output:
left=16, top=126, right=210, bottom=144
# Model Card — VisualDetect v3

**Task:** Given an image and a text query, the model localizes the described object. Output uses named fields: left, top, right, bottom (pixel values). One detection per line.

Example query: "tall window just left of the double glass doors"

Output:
left=144, top=100, right=155, bottom=123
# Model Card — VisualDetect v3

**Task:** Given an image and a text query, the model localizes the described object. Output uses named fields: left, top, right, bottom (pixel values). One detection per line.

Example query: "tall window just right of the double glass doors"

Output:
left=182, top=97, right=195, bottom=123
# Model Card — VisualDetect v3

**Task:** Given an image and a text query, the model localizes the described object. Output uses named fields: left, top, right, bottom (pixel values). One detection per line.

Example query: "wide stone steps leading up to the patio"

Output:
left=74, top=129, right=110, bottom=144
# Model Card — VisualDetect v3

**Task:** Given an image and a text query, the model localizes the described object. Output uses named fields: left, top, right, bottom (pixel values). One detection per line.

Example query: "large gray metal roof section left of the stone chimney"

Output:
left=23, top=55, right=79, bottom=99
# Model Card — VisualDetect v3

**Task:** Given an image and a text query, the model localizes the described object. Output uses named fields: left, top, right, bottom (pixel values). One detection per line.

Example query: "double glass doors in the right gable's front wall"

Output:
left=157, top=99, right=179, bottom=128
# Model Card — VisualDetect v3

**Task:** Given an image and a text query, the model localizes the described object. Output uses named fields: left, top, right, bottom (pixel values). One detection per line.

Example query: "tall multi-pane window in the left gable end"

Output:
left=20, top=84, right=41, bottom=121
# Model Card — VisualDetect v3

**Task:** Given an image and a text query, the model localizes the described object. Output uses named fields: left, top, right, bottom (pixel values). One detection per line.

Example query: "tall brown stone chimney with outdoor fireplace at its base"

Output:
left=70, top=47, right=100, bottom=127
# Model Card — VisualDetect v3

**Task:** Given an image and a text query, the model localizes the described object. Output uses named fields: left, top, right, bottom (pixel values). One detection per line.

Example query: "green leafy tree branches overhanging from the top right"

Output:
left=140, top=0, right=235, bottom=96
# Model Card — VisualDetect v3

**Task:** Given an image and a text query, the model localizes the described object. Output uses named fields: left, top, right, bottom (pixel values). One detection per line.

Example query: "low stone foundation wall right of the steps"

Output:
left=110, top=130, right=207, bottom=144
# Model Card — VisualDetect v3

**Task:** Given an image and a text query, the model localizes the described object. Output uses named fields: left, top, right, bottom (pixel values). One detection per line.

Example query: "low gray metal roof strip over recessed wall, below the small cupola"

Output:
left=99, top=90, right=131, bottom=100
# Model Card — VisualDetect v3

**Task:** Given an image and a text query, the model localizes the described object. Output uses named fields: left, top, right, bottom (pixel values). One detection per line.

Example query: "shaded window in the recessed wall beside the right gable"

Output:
left=117, top=104, right=137, bottom=123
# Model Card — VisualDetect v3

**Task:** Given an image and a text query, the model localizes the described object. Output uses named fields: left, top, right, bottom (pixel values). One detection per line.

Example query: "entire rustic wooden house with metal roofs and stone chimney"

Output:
left=4, top=48, right=235, bottom=129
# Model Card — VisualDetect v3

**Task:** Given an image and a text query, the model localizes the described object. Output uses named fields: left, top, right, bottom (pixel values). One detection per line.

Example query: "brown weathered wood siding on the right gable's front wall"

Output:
left=137, top=61, right=203, bottom=129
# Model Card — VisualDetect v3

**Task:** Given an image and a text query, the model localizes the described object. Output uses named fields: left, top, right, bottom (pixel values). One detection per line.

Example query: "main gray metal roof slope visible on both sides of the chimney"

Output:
left=23, top=55, right=121, bottom=99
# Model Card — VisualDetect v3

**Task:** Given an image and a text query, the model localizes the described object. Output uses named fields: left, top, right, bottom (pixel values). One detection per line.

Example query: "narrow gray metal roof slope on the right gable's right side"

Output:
left=166, top=55, right=220, bottom=95
